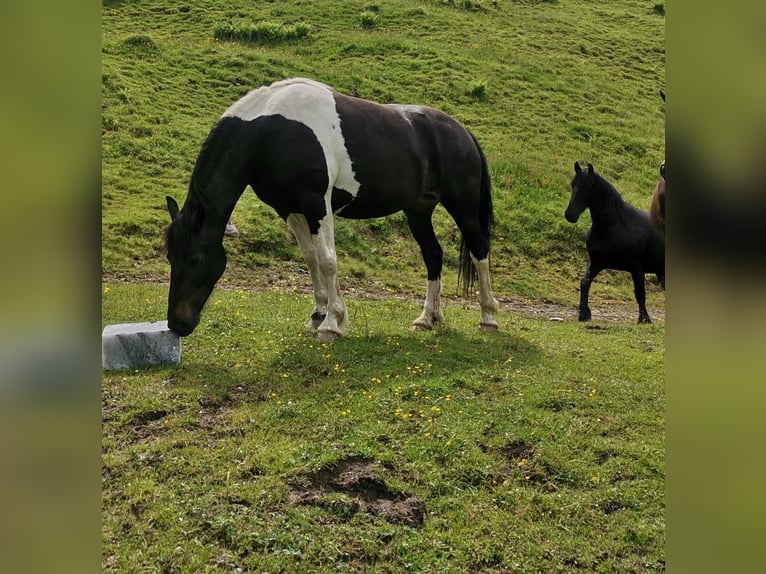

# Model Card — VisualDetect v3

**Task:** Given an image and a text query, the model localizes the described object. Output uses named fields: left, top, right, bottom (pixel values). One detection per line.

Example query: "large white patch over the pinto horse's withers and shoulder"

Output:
left=222, top=78, right=359, bottom=197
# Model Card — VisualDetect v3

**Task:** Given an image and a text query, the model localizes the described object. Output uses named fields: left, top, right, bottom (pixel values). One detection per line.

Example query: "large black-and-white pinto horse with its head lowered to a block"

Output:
left=166, top=78, right=499, bottom=341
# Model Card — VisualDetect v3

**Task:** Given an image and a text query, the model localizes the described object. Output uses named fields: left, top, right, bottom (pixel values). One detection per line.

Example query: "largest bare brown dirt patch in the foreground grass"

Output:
left=288, top=457, right=425, bottom=528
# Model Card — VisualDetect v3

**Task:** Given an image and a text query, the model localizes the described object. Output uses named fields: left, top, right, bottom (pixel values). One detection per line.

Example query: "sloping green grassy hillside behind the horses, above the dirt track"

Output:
left=102, top=0, right=664, bottom=307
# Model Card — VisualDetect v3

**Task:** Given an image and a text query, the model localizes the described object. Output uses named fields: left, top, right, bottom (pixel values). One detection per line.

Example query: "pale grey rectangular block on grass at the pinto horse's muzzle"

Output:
left=101, top=321, right=181, bottom=371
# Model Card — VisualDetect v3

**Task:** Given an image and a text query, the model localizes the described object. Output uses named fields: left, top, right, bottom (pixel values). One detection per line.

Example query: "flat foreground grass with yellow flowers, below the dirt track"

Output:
left=102, top=283, right=664, bottom=572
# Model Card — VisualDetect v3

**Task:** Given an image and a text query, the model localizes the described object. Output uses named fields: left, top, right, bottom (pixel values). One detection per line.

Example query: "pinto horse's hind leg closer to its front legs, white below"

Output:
left=405, top=211, right=444, bottom=330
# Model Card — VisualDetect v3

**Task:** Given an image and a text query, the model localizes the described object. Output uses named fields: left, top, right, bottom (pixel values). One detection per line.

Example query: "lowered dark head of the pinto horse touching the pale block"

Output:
left=165, top=197, right=226, bottom=337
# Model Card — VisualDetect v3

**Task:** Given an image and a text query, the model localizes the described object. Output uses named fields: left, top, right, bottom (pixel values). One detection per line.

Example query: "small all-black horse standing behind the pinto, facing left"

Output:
left=564, top=162, right=665, bottom=323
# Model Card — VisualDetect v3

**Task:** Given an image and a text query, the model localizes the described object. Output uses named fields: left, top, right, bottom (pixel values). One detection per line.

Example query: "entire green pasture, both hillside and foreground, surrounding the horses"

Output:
left=102, top=0, right=665, bottom=572
